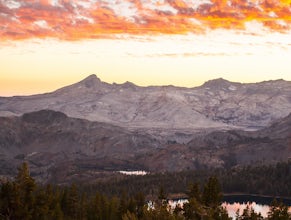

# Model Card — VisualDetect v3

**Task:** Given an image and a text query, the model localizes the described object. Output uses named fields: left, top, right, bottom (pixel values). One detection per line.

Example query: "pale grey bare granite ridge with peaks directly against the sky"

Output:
left=0, top=75, right=291, bottom=130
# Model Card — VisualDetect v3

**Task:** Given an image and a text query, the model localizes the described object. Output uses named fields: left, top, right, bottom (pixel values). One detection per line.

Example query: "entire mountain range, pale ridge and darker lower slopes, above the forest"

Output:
left=0, top=75, right=291, bottom=184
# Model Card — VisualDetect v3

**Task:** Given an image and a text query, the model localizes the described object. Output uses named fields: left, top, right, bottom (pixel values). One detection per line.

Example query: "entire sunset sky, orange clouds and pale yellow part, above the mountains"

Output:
left=0, top=0, right=291, bottom=96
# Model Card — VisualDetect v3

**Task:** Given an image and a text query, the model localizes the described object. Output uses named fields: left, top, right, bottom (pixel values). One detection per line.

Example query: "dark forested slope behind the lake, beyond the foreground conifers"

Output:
left=81, top=162, right=291, bottom=198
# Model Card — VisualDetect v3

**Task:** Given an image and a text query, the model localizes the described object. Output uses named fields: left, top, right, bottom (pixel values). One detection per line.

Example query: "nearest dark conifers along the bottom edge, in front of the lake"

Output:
left=0, top=163, right=291, bottom=220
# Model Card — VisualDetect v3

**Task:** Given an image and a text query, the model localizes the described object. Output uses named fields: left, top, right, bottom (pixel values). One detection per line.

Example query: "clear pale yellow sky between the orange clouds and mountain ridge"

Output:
left=0, top=30, right=291, bottom=96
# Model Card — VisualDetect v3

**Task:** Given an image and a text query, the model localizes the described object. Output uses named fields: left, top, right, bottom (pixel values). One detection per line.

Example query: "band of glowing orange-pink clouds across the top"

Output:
left=0, top=0, right=291, bottom=40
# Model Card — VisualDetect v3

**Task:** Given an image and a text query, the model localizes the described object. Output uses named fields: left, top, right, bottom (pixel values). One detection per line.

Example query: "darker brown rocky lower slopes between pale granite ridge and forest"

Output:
left=0, top=110, right=291, bottom=184
